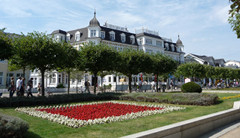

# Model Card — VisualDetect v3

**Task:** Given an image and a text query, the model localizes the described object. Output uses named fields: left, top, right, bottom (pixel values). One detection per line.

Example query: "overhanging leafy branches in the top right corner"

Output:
left=228, top=0, right=240, bottom=38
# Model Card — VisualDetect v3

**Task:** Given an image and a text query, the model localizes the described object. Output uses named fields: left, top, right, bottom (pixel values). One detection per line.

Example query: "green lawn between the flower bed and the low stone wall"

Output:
left=0, top=93, right=240, bottom=138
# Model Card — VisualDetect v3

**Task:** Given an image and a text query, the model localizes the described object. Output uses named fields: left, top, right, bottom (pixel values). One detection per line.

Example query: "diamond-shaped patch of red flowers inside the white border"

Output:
left=37, top=103, right=163, bottom=120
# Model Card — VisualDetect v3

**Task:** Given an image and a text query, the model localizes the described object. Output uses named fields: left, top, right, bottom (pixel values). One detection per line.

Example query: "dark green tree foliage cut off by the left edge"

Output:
left=0, top=29, right=14, bottom=60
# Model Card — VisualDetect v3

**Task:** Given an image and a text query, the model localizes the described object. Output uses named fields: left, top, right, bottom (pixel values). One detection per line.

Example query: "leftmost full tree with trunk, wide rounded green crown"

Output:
left=14, top=32, right=64, bottom=96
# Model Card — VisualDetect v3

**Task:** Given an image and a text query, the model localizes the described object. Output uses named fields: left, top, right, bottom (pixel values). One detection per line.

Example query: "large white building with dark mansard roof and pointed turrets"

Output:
left=31, top=12, right=184, bottom=87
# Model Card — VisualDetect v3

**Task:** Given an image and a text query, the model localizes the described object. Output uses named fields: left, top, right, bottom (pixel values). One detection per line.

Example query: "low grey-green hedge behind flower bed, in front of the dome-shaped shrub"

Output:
left=120, top=93, right=218, bottom=106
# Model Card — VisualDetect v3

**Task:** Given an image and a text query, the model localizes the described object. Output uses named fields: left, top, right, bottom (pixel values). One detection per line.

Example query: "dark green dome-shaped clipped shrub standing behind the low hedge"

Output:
left=181, top=82, right=202, bottom=93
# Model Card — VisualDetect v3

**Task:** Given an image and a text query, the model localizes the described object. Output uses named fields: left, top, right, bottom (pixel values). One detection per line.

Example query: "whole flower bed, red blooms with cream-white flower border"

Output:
left=16, top=101, right=185, bottom=128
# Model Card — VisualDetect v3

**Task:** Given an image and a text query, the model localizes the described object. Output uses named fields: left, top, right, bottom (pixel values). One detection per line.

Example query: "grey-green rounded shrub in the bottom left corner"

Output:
left=0, top=114, right=29, bottom=138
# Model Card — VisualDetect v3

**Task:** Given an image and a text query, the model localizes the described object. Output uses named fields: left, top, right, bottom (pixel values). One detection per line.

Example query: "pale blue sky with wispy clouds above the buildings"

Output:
left=0, top=0, right=240, bottom=61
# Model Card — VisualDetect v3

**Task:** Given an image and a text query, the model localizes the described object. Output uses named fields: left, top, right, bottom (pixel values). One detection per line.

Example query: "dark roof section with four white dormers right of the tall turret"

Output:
left=100, top=26, right=138, bottom=46
